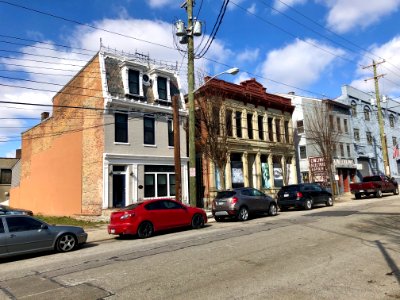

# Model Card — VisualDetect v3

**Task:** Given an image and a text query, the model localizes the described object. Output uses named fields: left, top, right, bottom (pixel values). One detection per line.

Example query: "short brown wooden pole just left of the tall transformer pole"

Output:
left=172, top=95, right=182, bottom=202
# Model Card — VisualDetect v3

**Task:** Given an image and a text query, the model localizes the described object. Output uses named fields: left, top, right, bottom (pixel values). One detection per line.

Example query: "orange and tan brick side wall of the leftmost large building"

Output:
left=10, top=56, right=104, bottom=215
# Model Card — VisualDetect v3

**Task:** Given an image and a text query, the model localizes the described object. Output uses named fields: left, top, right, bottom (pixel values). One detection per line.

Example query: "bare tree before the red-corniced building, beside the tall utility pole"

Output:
left=196, top=90, right=232, bottom=189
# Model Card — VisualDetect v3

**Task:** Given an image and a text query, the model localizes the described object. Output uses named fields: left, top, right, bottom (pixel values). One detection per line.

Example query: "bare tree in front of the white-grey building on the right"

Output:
left=305, top=100, right=339, bottom=194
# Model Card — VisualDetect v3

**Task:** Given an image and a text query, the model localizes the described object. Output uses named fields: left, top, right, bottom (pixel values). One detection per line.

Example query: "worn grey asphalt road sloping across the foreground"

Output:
left=0, top=196, right=400, bottom=300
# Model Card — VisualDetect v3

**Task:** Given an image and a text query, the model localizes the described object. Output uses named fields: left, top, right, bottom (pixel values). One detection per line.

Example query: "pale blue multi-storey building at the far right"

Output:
left=336, top=85, right=400, bottom=180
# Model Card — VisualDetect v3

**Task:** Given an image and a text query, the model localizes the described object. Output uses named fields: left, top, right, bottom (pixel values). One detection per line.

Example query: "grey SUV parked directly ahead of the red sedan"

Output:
left=212, top=188, right=278, bottom=222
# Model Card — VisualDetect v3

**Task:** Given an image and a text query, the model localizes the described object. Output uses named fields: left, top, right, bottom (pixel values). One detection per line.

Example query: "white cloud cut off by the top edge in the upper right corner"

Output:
left=319, top=0, right=400, bottom=33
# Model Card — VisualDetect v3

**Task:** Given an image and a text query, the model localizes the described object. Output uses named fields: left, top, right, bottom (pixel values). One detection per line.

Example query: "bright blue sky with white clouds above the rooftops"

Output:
left=0, top=0, right=400, bottom=157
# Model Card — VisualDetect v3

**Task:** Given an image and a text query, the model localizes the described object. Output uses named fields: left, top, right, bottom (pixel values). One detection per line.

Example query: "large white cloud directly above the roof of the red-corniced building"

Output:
left=260, top=39, right=344, bottom=92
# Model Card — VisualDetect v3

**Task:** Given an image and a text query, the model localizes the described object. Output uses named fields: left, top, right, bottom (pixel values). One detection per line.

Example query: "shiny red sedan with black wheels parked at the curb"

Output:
left=108, top=199, right=207, bottom=238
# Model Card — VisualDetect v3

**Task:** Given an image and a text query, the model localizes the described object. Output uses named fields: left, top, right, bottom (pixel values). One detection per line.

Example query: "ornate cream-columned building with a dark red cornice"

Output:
left=195, top=78, right=297, bottom=205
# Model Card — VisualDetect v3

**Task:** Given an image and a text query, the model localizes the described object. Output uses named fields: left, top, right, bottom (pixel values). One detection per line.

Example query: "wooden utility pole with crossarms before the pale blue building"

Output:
left=363, top=60, right=390, bottom=176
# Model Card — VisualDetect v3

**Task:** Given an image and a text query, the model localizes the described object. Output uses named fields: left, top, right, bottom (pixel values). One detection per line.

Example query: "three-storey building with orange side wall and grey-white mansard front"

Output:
left=11, top=48, right=188, bottom=215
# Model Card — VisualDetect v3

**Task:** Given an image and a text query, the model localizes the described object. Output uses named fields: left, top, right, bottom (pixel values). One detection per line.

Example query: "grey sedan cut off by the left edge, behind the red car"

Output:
left=0, top=215, right=87, bottom=258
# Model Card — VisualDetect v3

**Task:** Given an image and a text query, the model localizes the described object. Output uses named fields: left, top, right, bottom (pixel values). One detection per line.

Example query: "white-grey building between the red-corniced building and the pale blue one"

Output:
left=282, top=93, right=356, bottom=193
